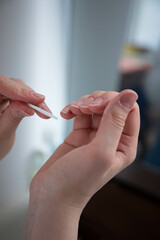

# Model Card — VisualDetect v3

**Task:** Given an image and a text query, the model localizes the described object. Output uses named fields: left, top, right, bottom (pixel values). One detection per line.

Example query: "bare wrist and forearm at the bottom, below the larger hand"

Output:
left=23, top=189, right=80, bottom=240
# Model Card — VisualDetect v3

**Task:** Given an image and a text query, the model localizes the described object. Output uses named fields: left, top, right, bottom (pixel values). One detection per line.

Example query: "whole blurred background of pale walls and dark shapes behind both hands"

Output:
left=0, top=0, right=160, bottom=240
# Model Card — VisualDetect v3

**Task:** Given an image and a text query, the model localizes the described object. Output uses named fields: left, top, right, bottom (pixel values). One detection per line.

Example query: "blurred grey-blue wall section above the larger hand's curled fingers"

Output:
left=70, top=0, right=131, bottom=101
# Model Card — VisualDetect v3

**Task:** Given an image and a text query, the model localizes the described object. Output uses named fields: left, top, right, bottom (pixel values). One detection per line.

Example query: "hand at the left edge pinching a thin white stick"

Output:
left=0, top=76, right=50, bottom=159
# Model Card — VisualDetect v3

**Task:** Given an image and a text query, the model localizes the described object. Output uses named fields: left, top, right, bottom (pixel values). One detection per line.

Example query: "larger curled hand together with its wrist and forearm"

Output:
left=23, top=90, right=140, bottom=240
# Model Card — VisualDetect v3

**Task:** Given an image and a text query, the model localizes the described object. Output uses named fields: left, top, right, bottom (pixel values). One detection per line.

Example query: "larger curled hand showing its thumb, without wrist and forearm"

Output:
left=33, top=90, right=140, bottom=209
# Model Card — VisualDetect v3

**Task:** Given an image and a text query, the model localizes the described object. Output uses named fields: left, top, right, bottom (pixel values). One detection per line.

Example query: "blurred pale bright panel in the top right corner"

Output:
left=128, top=0, right=160, bottom=51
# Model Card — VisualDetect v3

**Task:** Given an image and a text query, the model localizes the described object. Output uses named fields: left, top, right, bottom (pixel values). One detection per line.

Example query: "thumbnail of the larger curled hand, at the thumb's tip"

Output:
left=120, top=93, right=138, bottom=110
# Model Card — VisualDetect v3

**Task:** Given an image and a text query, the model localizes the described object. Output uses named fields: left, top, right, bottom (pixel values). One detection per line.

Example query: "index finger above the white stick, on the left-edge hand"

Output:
left=0, top=76, right=45, bottom=104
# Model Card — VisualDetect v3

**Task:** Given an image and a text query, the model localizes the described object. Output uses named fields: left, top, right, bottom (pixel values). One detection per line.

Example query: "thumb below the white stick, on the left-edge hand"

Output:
left=0, top=101, right=34, bottom=138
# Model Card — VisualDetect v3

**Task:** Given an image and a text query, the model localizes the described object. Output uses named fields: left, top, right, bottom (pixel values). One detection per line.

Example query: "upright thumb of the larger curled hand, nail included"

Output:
left=96, top=90, right=138, bottom=159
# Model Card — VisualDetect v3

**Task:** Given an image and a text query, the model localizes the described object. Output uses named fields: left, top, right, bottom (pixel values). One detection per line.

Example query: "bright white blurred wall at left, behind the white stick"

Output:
left=0, top=0, right=67, bottom=209
